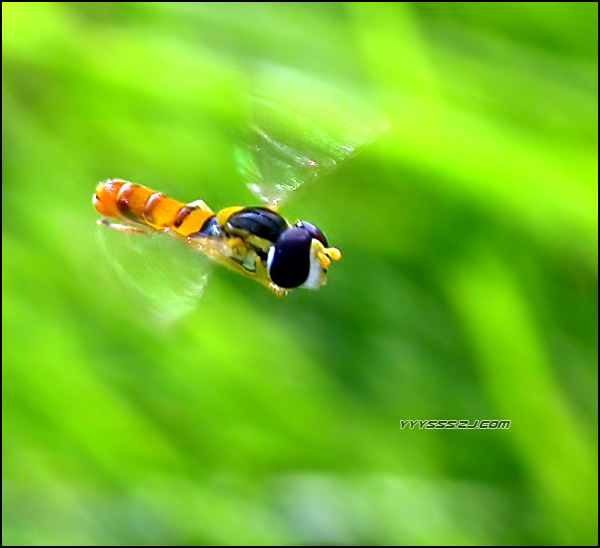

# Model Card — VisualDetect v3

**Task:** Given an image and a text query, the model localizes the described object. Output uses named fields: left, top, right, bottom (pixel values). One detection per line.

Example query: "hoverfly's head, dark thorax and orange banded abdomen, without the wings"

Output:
left=93, top=176, right=341, bottom=297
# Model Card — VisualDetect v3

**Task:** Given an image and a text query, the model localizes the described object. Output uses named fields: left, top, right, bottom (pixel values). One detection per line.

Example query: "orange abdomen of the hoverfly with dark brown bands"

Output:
left=94, top=179, right=213, bottom=236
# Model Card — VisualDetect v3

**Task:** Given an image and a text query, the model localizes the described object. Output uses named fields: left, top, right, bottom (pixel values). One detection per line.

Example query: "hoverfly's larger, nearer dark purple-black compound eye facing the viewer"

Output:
left=267, top=227, right=312, bottom=289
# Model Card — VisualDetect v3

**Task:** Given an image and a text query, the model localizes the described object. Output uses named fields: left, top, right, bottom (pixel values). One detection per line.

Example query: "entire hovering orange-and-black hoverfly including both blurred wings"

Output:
left=93, top=79, right=387, bottom=314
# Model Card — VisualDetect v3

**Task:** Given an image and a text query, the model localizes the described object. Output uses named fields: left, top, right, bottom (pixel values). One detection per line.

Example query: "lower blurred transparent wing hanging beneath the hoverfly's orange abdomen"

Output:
left=97, top=226, right=213, bottom=324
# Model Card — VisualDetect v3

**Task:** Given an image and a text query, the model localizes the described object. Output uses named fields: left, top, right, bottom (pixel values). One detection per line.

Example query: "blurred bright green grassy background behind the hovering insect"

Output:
left=2, top=2, right=598, bottom=545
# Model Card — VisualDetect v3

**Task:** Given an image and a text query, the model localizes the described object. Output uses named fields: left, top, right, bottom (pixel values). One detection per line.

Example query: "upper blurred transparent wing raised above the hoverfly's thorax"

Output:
left=237, top=67, right=387, bottom=206
